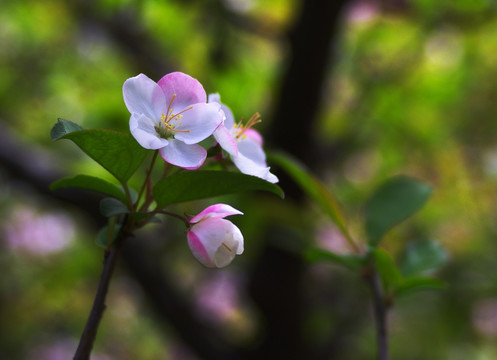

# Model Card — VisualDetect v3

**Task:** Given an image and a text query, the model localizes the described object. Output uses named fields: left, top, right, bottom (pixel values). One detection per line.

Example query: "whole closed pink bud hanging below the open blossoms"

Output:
left=187, top=204, right=243, bottom=268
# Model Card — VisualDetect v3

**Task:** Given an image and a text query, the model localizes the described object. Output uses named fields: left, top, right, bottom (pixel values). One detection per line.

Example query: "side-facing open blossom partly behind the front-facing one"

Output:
left=209, top=94, right=278, bottom=184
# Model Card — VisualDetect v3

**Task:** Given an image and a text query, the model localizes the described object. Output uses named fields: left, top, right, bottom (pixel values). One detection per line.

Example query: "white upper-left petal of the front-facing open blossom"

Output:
left=123, top=74, right=167, bottom=119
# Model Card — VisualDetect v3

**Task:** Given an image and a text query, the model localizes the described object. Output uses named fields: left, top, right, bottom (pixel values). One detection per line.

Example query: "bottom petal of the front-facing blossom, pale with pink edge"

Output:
left=159, top=139, right=207, bottom=170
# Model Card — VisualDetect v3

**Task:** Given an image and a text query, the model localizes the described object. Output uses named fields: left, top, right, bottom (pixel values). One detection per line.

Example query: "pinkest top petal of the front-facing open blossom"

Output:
left=158, top=72, right=207, bottom=109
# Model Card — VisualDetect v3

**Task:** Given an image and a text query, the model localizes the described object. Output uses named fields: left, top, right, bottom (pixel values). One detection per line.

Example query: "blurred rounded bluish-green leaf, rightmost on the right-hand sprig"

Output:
left=400, top=241, right=448, bottom=276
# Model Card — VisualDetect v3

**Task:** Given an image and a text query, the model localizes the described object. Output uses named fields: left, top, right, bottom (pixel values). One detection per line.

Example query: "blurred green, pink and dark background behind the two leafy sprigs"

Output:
left=0, top=0, right=497, bottom=360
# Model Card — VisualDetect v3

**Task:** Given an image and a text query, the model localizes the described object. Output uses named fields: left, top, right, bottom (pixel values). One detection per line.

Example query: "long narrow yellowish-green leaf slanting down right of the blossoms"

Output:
left=268, top=153, right=351, bottom=245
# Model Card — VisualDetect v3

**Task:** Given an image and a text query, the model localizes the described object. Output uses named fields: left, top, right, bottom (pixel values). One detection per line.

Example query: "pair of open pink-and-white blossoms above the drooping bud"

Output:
left=123, top=72, right=278, bottom=183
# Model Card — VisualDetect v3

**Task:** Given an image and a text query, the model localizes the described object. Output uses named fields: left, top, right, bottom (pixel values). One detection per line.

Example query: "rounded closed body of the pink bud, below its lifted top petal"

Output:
left=188, top=218, right=243, bottom=268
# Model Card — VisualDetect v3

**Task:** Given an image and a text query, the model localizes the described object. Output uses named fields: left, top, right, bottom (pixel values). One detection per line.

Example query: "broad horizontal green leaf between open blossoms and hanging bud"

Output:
left=152, top=171, right=283, bottom=208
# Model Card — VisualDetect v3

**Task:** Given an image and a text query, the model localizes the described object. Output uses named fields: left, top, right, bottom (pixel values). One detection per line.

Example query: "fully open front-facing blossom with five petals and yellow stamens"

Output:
left=123, top=72, right=224, bottom=169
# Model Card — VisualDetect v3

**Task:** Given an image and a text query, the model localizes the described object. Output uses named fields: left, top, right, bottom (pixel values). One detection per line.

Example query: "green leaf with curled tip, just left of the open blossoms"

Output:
left=52, top=119, right=148, bottom=183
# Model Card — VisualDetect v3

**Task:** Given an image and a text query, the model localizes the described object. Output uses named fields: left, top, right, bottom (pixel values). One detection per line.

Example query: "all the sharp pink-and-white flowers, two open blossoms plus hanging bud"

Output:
left=123, top=72, right=278, bottom=267
